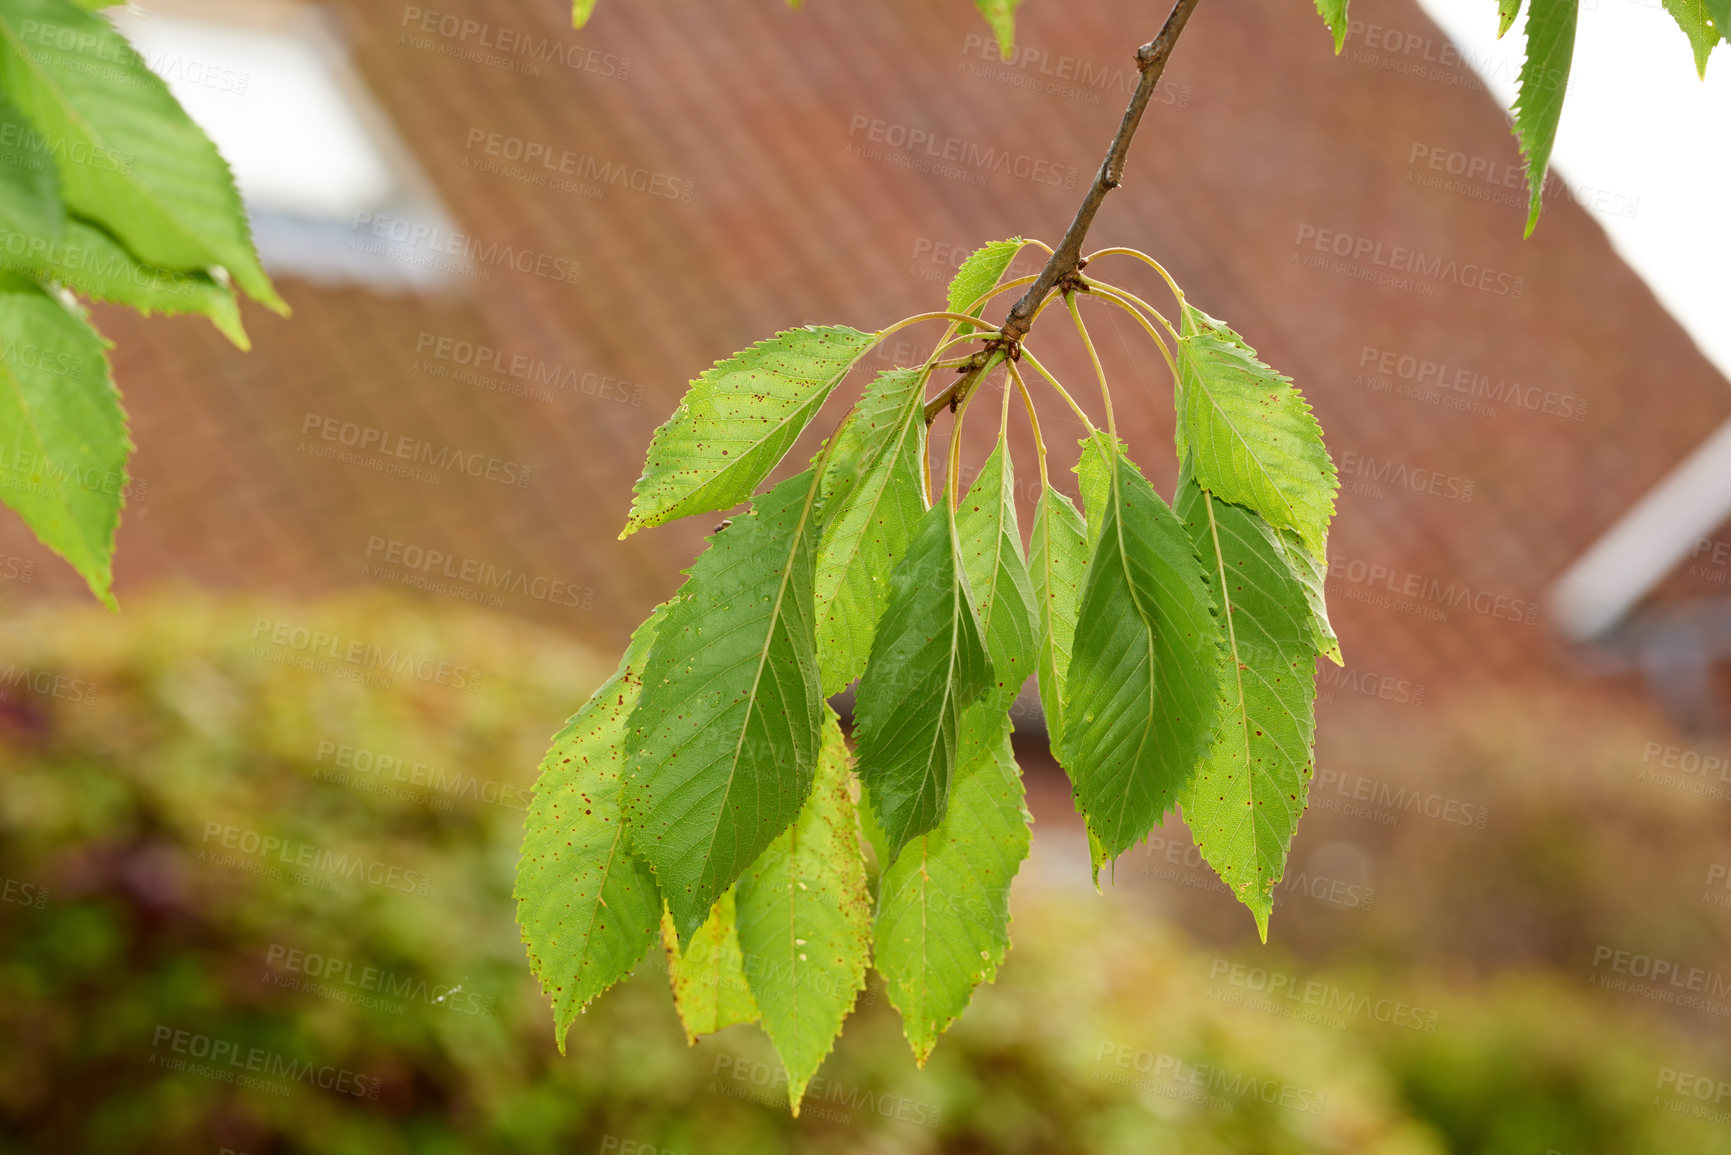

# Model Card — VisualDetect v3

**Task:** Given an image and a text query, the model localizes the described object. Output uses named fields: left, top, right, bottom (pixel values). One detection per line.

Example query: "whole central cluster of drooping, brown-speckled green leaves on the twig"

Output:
left=516, top=239, right=1340, bottom=1112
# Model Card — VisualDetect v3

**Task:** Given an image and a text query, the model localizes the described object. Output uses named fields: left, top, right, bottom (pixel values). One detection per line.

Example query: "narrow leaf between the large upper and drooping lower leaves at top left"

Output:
left=0, top=218, right=251, bottom=350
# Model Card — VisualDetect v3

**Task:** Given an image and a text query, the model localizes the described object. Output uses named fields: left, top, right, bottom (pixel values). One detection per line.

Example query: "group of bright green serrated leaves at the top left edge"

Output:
left=0, top=0, right=275, bottom=606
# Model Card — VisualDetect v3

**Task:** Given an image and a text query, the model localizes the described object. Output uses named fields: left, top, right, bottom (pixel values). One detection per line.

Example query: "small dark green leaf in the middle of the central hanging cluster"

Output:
left=853, top=500, right=992, bottom=861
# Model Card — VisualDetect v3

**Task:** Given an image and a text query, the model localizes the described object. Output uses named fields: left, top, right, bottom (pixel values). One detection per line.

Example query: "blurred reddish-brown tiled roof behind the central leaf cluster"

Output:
left=0, top=0, right=1731, bottom=706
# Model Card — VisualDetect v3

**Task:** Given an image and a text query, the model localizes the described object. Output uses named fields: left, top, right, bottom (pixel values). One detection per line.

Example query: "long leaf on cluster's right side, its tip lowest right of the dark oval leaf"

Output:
left=1177, top=471, right=1317, bottom=942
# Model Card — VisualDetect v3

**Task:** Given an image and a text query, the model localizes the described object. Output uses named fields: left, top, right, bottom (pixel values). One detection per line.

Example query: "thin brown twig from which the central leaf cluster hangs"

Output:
left=926, top=0, right=1200, bottom=424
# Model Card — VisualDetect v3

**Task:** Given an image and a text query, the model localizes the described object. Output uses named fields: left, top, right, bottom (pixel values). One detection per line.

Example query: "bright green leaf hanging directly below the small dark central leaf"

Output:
left=876, top=703, right=1032, bottom=1067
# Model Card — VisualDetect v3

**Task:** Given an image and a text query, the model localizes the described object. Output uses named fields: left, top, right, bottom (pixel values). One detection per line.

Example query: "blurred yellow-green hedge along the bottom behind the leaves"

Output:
left=0, top=597, right=1731, bottom=1155
